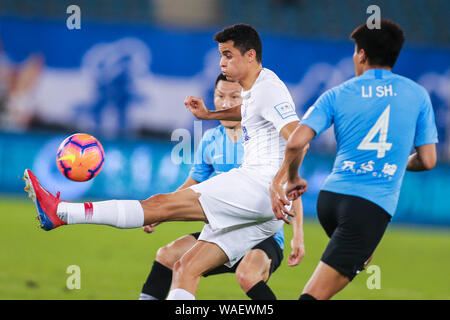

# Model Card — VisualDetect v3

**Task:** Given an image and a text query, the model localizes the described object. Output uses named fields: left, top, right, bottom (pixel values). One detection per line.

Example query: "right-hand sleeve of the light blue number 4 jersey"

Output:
left=414, top=92, right=438, bottom=147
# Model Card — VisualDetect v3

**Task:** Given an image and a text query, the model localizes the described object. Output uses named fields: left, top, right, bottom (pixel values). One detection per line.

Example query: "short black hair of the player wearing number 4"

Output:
left=350, top=19, right=405, bottom=68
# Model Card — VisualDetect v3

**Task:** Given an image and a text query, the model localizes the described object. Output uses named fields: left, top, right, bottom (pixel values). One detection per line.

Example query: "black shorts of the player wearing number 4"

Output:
left=317, top=190, right=391, bottom=281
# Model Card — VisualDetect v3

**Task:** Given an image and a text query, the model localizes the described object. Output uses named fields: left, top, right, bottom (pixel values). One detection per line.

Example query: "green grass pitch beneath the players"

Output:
left=0, top=196, right=450, bottom=300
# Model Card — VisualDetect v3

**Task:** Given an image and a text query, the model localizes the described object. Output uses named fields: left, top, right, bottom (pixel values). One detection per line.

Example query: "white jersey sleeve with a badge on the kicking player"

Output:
left=258, top=86, right=299, bottom=132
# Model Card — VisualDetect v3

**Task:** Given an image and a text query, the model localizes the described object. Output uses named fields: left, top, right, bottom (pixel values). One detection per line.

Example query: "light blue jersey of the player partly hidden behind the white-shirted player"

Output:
left=189, top=125, right=284, bottom=250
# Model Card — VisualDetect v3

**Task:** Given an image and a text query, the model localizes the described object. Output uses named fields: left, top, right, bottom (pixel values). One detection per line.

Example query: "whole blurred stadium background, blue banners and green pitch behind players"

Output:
left=0, top=0, right=450, bottom=299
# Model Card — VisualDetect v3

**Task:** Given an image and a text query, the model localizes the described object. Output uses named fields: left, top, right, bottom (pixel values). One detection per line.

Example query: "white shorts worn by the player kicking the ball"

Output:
left=190, top=167, right=284, bottom=267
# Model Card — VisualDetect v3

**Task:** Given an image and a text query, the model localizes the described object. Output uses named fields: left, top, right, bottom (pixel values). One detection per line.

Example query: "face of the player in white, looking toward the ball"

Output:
left=219, top=40, right=249, bottom=81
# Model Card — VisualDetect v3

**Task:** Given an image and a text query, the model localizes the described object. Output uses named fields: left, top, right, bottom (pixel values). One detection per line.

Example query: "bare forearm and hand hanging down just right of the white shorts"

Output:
left=288, top=198, right=305, bottom=267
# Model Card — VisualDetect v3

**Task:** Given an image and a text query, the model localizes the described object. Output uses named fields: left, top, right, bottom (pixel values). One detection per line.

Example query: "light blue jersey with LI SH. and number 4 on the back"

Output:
left=300, top=69, right=438, bottom=215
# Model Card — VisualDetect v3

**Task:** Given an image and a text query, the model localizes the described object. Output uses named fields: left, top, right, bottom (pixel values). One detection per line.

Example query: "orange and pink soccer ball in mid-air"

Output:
left=56, top=133, right=105, bottom=181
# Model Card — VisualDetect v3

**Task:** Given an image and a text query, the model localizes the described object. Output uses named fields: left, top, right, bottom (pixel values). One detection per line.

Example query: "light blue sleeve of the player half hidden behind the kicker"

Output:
left=189, top=132, right=214, bottom=183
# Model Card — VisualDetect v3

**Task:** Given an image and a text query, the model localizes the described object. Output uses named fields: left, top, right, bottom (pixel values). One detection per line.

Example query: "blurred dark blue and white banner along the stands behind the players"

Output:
left=0, top=17, right=450, bottom=159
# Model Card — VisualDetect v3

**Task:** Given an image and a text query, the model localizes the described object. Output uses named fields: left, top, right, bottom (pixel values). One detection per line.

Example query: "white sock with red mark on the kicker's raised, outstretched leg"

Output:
left=56, top=200, right=144, bottom=229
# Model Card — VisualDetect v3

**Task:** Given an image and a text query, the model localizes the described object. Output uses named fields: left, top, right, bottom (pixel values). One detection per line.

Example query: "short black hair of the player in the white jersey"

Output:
left=214, top=23, right=262, bottom=63
